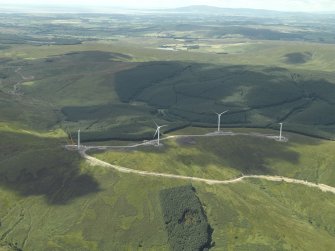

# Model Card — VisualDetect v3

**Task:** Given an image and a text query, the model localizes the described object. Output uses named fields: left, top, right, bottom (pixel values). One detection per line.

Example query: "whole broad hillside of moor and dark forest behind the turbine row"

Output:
left=0, top=47, right=335, bottom=141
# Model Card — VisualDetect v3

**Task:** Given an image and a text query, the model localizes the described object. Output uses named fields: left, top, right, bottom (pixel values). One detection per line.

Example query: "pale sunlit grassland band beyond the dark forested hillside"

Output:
left=0, top=37, right=335, bottom=72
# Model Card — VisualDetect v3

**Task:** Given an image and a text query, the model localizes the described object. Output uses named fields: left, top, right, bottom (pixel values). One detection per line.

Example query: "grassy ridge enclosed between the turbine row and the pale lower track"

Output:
left=95, top=129, right=335, bottom=185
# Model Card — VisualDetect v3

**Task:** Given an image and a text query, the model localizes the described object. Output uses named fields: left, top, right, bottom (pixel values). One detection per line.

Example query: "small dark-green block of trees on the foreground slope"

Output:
left=160, top=185, right=213, bottom=251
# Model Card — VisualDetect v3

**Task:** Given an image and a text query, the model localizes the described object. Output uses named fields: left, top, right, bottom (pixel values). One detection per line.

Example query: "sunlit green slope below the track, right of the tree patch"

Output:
left=195, top=180, right=335, bottom=251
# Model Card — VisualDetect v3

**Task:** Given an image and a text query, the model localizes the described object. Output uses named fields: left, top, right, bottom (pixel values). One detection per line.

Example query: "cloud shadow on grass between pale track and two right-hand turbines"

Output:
left=178, top=136, right=300, bottom=174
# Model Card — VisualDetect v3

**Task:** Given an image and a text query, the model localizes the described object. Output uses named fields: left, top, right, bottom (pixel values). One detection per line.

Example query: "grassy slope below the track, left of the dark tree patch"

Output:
left=0, top=125, right=173, bottom=250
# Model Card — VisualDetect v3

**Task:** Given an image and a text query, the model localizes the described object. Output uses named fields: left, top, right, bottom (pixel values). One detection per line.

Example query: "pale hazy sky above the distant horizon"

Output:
left=0, top=0, right=335, bottom=12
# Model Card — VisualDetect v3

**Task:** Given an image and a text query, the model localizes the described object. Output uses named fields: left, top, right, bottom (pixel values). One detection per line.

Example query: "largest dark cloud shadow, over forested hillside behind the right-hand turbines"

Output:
left=115, top=61, right=335, bottom=138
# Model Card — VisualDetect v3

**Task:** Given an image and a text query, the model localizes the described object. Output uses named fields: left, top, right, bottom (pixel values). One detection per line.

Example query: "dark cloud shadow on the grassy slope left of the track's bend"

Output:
left=0, top=133, right=100, bottom=205
